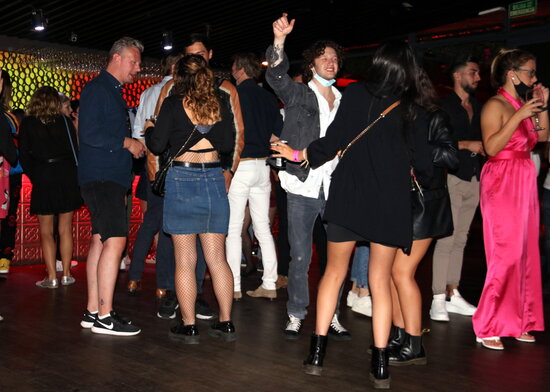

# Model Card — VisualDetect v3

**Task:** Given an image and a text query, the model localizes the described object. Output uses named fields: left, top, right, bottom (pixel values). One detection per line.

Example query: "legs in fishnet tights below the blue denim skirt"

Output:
left=172, top=233, right=233, bottom=325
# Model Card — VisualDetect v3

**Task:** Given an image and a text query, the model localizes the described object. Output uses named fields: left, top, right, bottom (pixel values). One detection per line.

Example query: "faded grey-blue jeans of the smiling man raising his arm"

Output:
left=287, top=189, right=326, bottom=319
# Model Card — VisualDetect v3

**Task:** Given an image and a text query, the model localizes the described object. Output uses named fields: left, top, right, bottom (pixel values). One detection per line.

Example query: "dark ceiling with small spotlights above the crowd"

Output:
left=0, top=0, right=507, bottom=66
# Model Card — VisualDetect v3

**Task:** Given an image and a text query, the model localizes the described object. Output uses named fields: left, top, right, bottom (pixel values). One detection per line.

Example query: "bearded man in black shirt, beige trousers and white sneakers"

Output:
left=430, top=55, right=485, bottom=321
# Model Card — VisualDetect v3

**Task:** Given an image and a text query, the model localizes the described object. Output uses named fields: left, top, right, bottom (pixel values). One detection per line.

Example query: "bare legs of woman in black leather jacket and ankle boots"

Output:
left=392, top=238, right=432, bottom=336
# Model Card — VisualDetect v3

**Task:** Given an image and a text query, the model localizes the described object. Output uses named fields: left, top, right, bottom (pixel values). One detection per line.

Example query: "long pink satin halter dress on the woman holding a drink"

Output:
left=473, top=89, right=544, bottom=338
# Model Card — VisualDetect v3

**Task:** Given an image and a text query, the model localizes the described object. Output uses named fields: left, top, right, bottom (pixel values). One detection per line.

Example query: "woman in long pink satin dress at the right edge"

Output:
left=473, top=49, right=549, bottom=350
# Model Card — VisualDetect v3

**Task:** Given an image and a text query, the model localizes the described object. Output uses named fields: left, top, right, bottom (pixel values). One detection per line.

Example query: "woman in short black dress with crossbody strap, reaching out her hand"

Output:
left=273, top=43, right=442, bottom=388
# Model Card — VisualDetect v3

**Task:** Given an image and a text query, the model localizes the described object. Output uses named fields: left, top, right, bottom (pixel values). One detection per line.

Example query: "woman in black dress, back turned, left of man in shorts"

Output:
left=19, top=86, right=82, bottom=289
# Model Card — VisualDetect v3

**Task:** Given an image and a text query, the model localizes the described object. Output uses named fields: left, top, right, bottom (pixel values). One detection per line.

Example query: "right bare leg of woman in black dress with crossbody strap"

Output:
left=369, top=242, right=397, bottom=348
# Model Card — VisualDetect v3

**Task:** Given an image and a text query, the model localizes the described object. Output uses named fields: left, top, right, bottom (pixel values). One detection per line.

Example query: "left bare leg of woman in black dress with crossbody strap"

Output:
left=315, top=241, right=355, bottom=336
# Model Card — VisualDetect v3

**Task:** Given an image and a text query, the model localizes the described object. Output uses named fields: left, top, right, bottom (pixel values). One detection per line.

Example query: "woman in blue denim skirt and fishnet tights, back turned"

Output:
left=146, top=55, right=239, bottom=344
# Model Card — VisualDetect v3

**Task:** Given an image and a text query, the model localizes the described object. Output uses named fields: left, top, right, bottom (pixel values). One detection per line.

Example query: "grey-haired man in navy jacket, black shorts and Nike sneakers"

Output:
left=78, top=37, right=145, bottom=336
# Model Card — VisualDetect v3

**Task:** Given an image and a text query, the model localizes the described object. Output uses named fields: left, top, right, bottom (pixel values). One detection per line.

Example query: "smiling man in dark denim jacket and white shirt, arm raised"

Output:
left=266, top=14, right=350, bottom=340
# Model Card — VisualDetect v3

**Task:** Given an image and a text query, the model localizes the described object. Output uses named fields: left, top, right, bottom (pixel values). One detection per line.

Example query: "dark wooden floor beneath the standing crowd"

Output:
left=0, top=214, right=550, bottom=392
